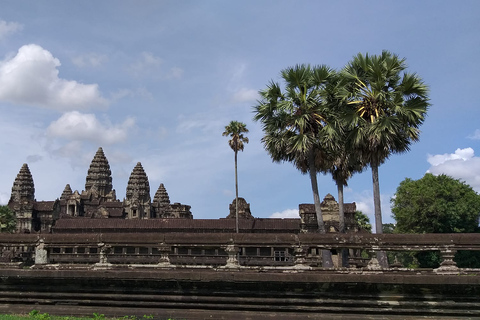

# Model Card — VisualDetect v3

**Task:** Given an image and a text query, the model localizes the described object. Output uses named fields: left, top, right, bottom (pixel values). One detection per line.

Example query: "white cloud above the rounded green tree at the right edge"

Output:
left=427, top=148, right=480, bottom=192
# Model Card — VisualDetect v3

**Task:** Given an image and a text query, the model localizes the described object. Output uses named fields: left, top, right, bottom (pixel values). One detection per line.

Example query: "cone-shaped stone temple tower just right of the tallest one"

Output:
left=124, top=162, right=152, bottom=219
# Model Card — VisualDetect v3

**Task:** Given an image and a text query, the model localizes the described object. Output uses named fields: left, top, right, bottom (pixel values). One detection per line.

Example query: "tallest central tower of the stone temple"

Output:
left=85, top=147, right=115, bottom=200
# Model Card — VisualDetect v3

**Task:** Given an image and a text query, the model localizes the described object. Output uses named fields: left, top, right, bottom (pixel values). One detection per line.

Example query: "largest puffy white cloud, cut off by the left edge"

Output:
left=0, top=44, right=108, bottom=110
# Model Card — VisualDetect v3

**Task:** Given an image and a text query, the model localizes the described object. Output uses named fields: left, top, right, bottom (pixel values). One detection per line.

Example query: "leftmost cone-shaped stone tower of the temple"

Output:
left=8, top=163, right=36, bottom=232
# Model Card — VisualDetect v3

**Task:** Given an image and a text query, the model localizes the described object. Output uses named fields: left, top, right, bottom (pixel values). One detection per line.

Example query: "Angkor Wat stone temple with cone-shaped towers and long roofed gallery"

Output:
left=8, top=148, right=358, bottom=233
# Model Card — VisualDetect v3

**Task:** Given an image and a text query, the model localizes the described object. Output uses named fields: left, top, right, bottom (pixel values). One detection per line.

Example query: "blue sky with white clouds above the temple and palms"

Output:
left=0, top=0, right=480, bottom=230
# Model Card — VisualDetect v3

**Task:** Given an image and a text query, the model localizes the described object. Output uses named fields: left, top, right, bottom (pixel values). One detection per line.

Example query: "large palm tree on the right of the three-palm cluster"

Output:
left=341, top=51, right=429, bottom=266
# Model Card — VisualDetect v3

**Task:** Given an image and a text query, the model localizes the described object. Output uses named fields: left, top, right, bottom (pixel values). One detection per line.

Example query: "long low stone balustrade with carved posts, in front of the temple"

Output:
left=0, top=233, right=480, bottom=273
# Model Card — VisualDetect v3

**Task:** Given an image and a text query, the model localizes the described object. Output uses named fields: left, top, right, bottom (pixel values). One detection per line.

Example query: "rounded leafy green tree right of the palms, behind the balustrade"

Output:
left=391, top=173, right=480, bottom=267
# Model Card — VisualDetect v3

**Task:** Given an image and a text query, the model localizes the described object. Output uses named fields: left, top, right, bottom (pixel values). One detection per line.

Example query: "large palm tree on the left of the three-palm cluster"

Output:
left=254, top=64, right=335, bottom=267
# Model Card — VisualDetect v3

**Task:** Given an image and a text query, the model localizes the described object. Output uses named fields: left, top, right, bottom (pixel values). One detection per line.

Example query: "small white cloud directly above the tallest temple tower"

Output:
left=47, top=111, right=135, bottom=145
